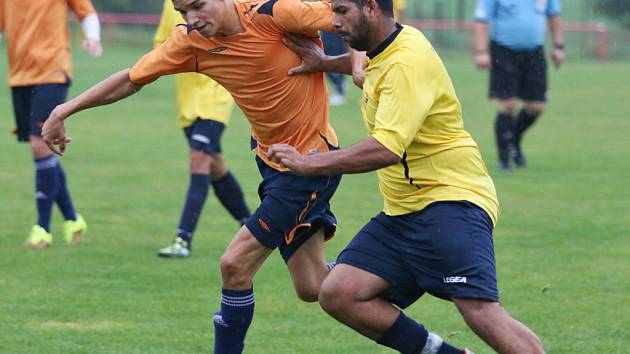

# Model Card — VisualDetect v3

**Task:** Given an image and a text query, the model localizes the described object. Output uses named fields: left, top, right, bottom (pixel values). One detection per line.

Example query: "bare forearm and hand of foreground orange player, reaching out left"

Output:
left=42, top=69, right=142, bottom=155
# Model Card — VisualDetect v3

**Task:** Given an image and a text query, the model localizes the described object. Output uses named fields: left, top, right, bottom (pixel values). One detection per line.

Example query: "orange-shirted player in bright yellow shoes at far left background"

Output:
left=0, top=0, right=102, bottom=249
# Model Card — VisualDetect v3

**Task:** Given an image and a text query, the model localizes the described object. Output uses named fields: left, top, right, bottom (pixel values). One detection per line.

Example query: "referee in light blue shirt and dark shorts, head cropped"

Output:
left=475, top=0, right=565, bottom=170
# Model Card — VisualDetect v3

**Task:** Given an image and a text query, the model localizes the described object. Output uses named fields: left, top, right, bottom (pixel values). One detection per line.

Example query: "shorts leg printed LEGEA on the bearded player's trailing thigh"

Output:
left=408, top=201, right=499, bottom=301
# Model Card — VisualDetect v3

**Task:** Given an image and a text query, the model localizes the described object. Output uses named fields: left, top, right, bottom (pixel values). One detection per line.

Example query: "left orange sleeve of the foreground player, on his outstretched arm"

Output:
left=129, top=26, right=197, bottom=85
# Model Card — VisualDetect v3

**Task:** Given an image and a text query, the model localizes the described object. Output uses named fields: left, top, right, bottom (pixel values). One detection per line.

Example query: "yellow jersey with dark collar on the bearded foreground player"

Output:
left=361, top=25, right=499, bottom=223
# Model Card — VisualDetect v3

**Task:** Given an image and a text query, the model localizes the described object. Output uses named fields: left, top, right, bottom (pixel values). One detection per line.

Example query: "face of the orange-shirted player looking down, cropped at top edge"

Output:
left=173, top=0, right=225, bottom=37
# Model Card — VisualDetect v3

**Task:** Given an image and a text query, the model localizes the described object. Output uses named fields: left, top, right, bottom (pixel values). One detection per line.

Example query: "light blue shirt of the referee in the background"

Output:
left=475, top=0, right=560, bottom=50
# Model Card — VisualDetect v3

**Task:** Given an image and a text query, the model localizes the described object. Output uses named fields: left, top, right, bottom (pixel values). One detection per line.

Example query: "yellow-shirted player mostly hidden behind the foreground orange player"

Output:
left=154, top=0, right=249, bottom=257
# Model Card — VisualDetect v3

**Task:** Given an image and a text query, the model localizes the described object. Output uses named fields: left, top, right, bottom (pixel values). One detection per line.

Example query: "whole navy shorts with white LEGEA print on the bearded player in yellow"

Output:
left=337, top=201, right=499, bottom=308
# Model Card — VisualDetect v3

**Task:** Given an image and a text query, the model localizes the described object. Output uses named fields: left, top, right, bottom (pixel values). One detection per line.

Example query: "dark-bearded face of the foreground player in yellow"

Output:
left=332, top=0, right=370, bottom=51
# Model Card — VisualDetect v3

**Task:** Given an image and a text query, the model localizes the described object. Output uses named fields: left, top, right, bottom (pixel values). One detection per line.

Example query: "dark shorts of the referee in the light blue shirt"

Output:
left=490, top=41, right=547, bottom=102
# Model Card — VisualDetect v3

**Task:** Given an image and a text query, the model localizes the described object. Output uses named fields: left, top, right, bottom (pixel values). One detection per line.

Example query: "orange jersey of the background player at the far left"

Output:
left=0, top=0, right=96, bottom=87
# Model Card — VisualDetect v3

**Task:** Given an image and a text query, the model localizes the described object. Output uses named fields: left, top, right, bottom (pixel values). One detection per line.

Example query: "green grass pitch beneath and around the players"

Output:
left=0, top=42, right=630, bottom=354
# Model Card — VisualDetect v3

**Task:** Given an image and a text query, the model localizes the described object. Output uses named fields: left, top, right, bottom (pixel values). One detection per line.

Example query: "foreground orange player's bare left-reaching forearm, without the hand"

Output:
left=58, top=69, right=142, bottom=120
